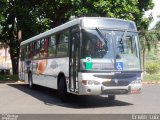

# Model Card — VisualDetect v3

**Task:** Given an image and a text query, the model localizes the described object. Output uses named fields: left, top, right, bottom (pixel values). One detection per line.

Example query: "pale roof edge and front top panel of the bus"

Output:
left=21, top=17, right=137, bottom=45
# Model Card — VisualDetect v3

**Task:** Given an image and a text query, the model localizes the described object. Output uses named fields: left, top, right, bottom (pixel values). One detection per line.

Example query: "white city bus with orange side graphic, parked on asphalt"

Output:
left=19, top=17, right=142, bottom=100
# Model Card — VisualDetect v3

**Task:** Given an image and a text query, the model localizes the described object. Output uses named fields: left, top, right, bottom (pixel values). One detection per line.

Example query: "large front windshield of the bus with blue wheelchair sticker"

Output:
left=81, top=29, right=140, bottom=70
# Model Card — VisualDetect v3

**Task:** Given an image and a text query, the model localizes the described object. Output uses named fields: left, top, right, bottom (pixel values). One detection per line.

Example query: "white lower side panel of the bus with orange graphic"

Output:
left=20, top=57, right=69, bottom=89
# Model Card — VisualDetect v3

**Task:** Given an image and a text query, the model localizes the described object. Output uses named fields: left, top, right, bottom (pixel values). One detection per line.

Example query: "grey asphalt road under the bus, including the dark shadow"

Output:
left=0, top=83, right=160, bottom=114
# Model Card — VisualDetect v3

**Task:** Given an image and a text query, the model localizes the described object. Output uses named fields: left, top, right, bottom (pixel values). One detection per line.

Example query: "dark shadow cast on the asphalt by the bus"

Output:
left=7, top=83, right=133, bottom=109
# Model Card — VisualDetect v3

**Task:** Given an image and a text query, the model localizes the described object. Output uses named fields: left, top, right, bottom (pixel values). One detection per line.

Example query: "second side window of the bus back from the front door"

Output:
left=48, top=35, right=56, bottom=57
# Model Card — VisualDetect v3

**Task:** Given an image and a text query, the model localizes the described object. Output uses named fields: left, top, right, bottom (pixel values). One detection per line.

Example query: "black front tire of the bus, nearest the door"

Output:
left=58, top=77, right=68, bottom=102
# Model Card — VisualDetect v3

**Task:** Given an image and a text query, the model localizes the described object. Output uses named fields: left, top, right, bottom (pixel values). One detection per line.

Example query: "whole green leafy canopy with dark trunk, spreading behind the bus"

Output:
left=0, top=0, right=153, bottom=74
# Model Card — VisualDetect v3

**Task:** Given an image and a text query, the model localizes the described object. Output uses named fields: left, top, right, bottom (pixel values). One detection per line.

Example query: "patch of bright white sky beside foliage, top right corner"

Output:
left=145, top=0, right=160, bottom=29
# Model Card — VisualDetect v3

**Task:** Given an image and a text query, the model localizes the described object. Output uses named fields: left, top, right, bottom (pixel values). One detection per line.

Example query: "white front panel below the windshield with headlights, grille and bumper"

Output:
left=78, top=72, right=142, bottom=95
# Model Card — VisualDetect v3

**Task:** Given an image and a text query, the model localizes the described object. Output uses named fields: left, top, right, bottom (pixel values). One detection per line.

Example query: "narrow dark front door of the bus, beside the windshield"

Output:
left=69, top=33, right=79, bottom=92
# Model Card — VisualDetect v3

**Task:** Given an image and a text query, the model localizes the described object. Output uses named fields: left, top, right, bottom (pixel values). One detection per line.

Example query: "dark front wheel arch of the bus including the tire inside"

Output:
left=57, top=72, right=68, bottom=102
